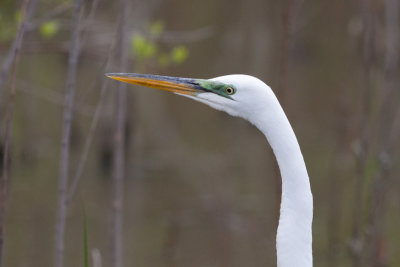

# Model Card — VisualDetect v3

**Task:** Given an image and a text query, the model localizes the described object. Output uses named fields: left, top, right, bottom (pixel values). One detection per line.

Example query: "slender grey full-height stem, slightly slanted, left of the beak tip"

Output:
left=54, top=0, right=84, bottom=267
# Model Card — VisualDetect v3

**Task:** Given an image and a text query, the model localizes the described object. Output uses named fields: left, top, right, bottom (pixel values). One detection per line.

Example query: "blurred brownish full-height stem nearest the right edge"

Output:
left=370, top=0, right=399, bottom=267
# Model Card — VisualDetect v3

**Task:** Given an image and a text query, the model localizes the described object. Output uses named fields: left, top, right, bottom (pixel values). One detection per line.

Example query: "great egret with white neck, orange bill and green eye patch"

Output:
left=106, top=73, right=313, bottom=267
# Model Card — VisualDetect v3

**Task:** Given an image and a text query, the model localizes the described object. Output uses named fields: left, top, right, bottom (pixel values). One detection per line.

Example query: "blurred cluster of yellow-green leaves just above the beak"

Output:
left=131, top=21, right=189, bottom=67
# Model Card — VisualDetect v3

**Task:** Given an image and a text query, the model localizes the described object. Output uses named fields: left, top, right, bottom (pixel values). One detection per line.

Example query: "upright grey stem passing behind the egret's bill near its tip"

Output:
left=113, top=0, right=128, bottom=267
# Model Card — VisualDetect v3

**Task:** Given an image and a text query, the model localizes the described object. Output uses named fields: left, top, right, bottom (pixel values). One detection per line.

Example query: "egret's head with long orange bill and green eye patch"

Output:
left=106, top=73, right=276, bottom=123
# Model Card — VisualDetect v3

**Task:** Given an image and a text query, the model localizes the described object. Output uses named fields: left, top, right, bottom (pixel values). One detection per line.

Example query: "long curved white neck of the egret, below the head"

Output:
left=250, top=97, right=313, bottom=267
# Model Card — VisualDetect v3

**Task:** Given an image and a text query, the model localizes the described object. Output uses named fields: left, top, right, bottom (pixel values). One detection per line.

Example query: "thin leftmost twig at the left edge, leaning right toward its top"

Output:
left=0, top=0, right=33, bottom=267
